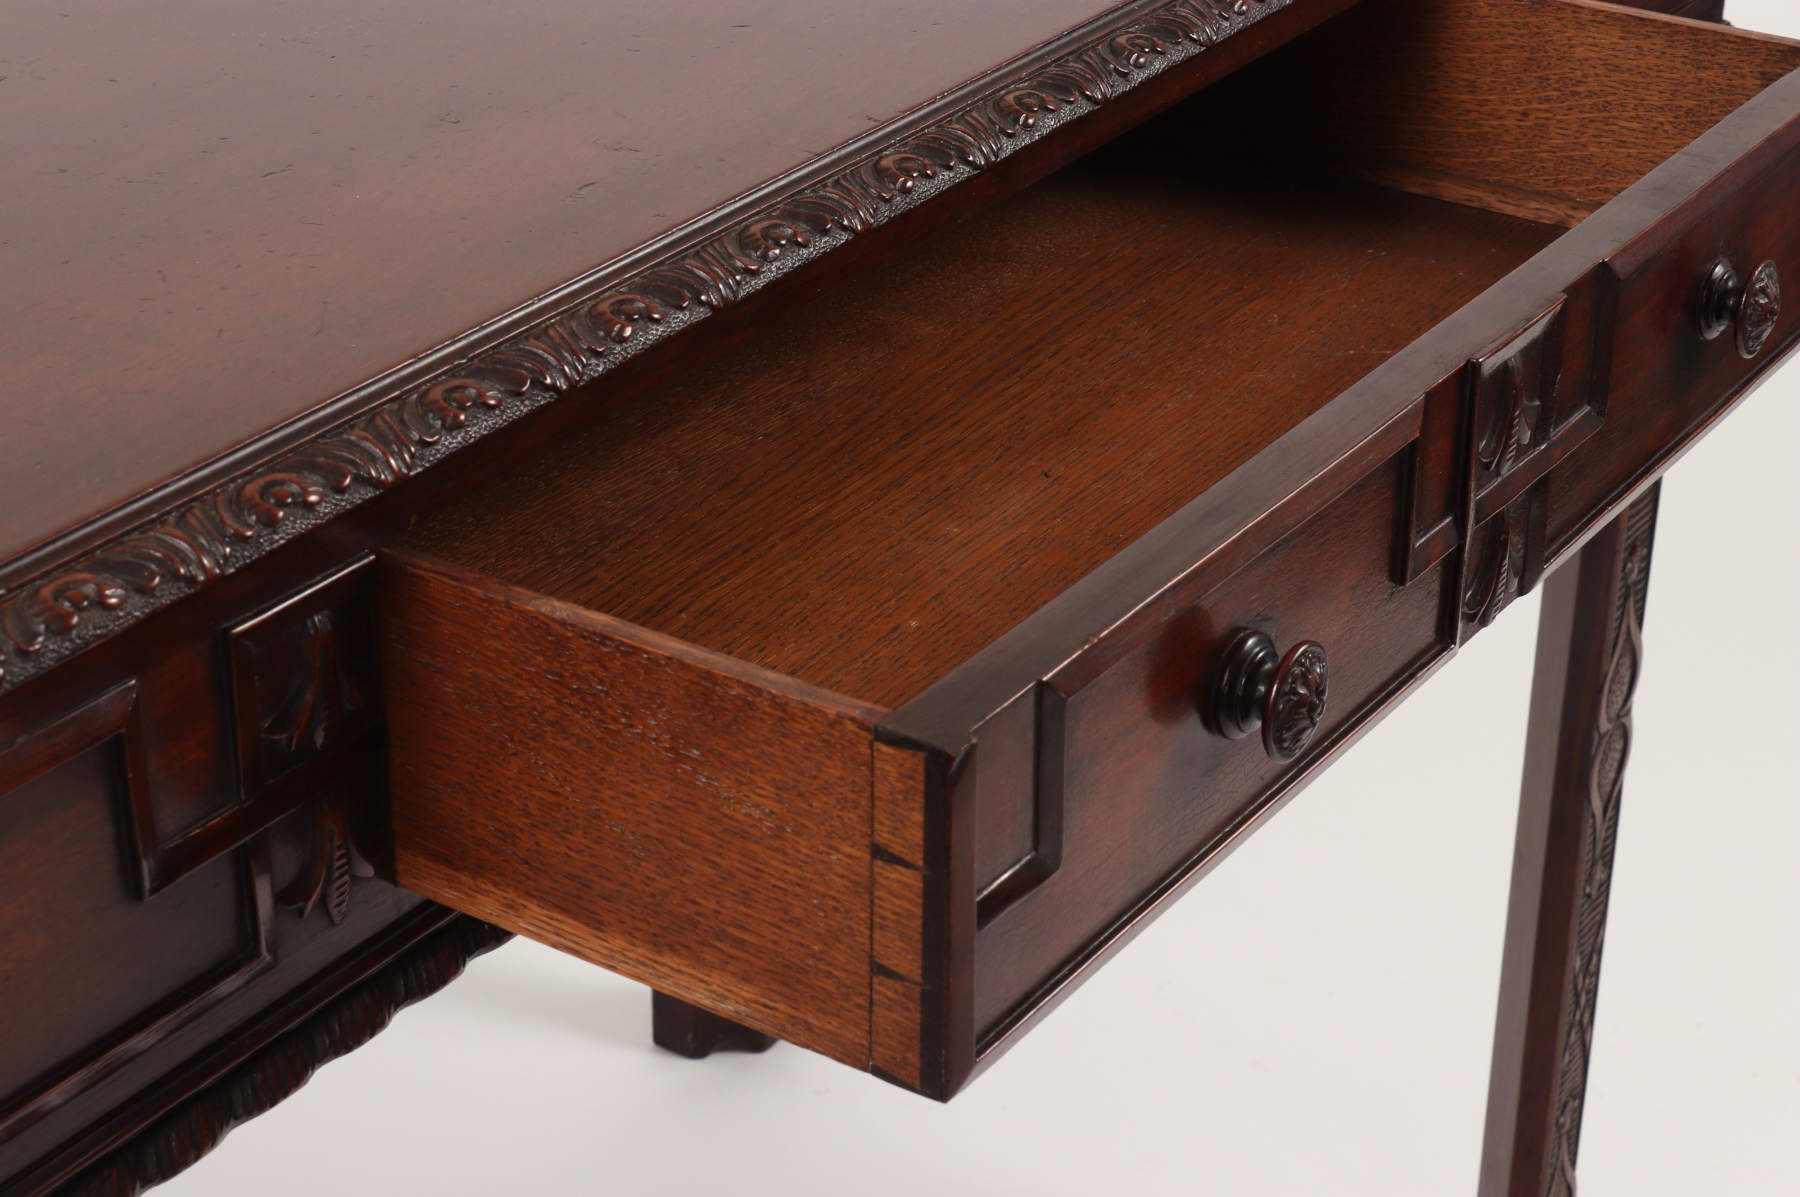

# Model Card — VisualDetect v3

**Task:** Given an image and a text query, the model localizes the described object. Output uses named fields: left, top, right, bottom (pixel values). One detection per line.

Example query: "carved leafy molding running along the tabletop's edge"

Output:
left=0, top=0, right=1294, bottom=689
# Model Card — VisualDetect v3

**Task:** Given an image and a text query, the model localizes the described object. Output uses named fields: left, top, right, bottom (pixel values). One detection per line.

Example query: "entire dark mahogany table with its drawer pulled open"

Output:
left=0, top=0, right=1800, bottom=1195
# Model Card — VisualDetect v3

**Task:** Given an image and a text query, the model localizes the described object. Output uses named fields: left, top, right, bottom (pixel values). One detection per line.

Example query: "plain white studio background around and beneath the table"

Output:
left=160, top=0, right=1800, bottom=1197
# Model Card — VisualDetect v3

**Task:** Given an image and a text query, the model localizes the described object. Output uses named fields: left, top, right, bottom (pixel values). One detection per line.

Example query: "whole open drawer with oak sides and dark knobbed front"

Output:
left=380, top=0, right=1800, bottom=1096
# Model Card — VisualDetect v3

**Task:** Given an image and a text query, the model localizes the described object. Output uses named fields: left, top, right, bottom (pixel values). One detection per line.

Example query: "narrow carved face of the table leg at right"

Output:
left=1548, top=497, right=1656, bottom=1197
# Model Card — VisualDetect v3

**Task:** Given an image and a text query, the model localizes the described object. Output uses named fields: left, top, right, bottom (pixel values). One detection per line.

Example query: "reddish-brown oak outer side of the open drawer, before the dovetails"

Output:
left=382, top=556, right=873, bottom=1067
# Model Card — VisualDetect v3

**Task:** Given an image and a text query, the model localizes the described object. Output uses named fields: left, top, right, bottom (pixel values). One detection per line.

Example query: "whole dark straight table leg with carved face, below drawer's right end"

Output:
left=1480, top=484, right=1661, bottom=1197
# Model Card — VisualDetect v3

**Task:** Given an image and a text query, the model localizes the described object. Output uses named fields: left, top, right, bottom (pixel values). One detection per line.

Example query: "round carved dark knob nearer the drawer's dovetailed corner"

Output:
left=1208, top=628, right=1330, bottom=761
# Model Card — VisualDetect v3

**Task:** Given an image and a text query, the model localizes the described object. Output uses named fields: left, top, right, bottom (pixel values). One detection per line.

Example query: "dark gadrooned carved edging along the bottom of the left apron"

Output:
left=59, top=916, right=511, bottom=1197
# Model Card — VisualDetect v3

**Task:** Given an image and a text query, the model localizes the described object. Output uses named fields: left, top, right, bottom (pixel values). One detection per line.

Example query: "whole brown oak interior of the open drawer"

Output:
left=410, top=0, right=1795, bottom=709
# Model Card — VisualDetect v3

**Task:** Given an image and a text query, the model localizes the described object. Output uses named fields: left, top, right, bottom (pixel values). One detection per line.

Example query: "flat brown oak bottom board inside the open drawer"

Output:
left=409, top=164, right=1552, bottom=707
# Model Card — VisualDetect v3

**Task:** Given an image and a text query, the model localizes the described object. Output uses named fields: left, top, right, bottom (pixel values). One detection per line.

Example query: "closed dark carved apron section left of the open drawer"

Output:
left=0, top=545, right=460, bottom=1197
